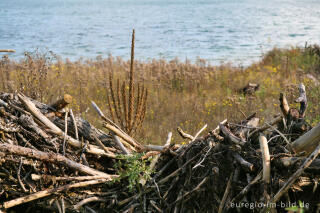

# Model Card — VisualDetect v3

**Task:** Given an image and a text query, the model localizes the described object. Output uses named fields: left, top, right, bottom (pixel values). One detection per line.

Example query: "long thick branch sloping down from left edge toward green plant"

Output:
left=0, top=143, right=113, bottom=180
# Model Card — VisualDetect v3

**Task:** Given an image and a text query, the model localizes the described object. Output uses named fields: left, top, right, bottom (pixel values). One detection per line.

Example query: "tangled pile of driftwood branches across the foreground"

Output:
left=0, top=84, right=320, bottom=212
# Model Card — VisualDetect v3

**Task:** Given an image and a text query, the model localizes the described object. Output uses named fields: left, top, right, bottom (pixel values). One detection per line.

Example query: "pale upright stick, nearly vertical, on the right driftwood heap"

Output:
left=259, top=134, right=270, bottom=184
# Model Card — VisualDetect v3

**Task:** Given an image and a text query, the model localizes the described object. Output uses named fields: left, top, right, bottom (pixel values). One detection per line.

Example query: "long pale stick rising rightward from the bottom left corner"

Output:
left=3, top=179, right=108, bottom=209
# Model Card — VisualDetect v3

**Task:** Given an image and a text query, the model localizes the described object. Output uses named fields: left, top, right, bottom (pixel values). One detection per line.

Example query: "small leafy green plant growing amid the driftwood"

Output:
left=115, top=153, right=153, bottom=192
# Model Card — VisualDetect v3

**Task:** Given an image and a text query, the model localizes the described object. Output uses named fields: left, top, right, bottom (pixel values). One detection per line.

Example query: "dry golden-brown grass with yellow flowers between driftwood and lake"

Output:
left=0, top=45, right=320, bottom=143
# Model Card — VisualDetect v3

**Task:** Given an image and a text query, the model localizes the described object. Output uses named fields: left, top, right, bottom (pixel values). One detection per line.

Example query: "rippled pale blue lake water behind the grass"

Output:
left=0, top=0, right=320, bottom=63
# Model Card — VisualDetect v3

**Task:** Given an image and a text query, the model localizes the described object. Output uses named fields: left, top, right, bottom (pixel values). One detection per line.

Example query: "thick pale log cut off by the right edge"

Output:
left=292, top=123, right=320, bottom=154
